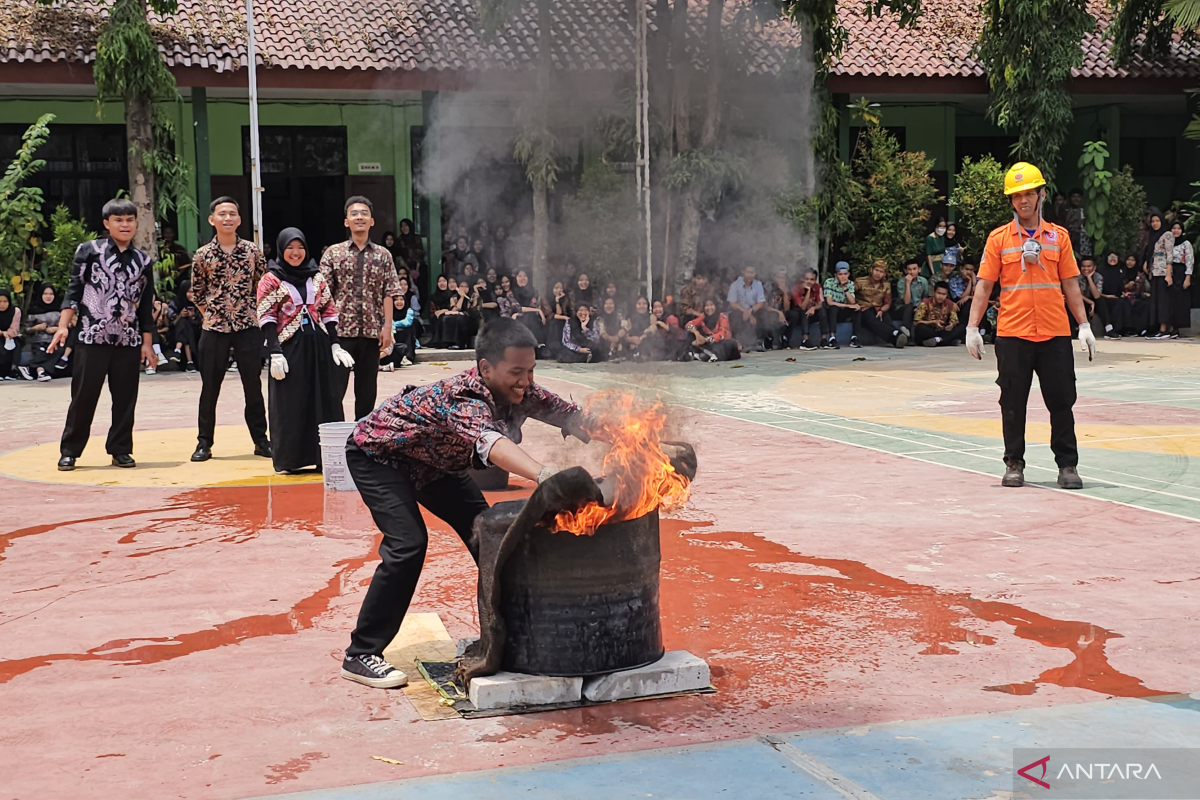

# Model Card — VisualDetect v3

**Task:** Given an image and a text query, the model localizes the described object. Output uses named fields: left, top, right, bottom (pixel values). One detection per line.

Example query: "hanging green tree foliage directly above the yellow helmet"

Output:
left=976, top=0, right=1096, bottom=186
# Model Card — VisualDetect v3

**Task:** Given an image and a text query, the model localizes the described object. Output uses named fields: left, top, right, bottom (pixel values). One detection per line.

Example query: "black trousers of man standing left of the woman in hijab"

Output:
left=196, top=327, right=266, bottom=447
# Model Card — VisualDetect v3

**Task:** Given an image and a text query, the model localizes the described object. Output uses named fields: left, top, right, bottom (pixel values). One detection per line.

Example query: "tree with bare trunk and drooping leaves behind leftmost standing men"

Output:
left=38, top=0, right=180, bottom=257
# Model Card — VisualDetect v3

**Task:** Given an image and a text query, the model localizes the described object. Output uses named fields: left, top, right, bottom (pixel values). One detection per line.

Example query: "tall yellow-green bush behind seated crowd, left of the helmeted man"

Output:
left=846, top=125, right=937, bottom=275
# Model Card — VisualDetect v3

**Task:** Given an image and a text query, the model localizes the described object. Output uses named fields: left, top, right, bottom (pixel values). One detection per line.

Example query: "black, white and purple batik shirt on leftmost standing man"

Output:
left=62, top=239, right=155, bottom=347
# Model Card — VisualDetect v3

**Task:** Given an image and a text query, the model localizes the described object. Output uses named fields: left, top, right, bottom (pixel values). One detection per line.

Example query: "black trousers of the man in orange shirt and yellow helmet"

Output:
left=996, top=336, right=1079, bottom=468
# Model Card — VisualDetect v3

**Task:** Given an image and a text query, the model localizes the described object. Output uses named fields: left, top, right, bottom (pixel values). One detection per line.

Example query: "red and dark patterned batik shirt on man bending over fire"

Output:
left=352, top=368, right=582, bottom=487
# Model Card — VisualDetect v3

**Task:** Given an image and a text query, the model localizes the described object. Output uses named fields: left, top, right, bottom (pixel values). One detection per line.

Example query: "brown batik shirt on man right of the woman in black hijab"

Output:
left=320, top=240, right=400, bottom=338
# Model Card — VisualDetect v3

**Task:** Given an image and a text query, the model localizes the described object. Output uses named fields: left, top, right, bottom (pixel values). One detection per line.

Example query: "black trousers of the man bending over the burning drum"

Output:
left=346, top=443, right=487, bottom=656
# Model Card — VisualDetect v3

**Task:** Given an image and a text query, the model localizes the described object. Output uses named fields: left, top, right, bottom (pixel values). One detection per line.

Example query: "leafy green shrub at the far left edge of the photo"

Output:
left=0, top=114, right=54, bottom=307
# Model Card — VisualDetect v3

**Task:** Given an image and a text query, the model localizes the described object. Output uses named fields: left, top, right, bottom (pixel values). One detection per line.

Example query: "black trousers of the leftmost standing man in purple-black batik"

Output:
left=59, top=344, right=142, bottom=458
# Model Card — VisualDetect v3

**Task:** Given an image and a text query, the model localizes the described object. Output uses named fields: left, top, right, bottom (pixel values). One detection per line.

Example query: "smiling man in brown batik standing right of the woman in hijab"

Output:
left=320, top=196, right=400, bottom=420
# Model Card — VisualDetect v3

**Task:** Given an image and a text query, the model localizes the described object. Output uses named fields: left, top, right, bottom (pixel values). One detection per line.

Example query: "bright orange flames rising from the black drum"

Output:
left=554, top=392, right=690, bottom=536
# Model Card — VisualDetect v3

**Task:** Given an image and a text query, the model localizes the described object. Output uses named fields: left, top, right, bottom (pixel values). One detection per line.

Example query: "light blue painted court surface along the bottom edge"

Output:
left=243, top=696, right=1200, bottom=800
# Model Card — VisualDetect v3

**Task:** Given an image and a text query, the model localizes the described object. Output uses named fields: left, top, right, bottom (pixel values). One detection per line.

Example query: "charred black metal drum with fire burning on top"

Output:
left=480, top=501, right=662, bottom=675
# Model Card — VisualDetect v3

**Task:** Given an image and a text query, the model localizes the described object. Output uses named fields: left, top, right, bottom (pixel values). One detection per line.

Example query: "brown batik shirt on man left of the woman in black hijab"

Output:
left=188, top=239, right=266, bottom=333
